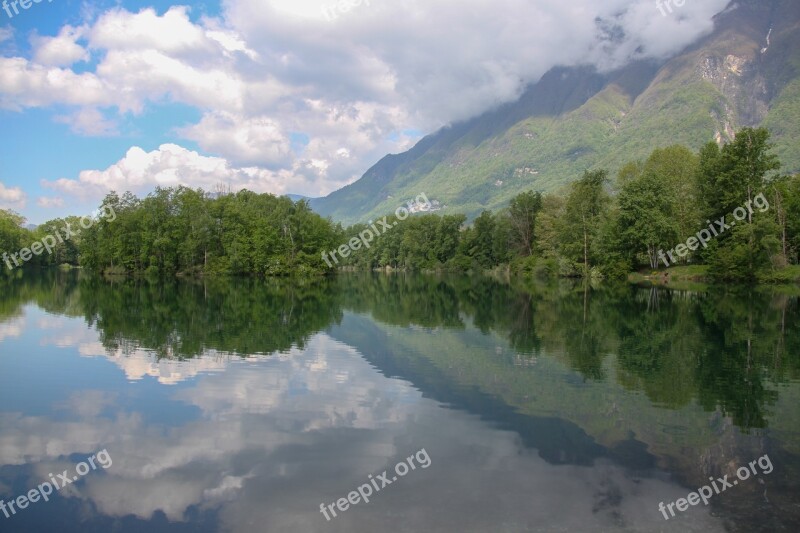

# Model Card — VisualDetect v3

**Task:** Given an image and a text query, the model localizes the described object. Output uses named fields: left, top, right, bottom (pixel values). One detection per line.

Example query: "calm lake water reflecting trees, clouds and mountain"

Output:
left=0, top=273, right=800, bottom=533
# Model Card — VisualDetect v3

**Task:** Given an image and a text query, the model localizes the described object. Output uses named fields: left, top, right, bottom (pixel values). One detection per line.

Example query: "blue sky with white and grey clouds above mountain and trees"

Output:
left=0, top=0, right=729, bottom=224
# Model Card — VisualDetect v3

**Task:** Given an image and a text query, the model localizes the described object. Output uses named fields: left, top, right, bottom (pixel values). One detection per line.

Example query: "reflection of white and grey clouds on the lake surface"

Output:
left=0, top=308, right=722, bottom=533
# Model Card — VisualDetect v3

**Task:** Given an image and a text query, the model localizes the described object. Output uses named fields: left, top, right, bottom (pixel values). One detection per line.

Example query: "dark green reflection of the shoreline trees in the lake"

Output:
left=0, top=271, right=800, bottom=429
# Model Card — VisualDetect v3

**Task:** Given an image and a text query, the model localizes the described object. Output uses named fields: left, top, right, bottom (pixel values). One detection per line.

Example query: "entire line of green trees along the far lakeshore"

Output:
left=0, top=128, right=800, bottom=281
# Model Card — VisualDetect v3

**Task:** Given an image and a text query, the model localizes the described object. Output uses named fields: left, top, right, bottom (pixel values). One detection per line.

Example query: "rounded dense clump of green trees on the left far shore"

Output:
left=81, top=187, right=339, bottom=276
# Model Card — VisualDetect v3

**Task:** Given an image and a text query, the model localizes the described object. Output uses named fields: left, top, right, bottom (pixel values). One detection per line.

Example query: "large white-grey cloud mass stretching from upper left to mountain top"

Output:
left=0, top=0, right=728, bottom=200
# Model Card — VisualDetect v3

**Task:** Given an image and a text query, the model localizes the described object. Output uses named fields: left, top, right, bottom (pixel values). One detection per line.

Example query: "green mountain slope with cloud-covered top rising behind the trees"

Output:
left=311, top=0, right=800, bottom=223
